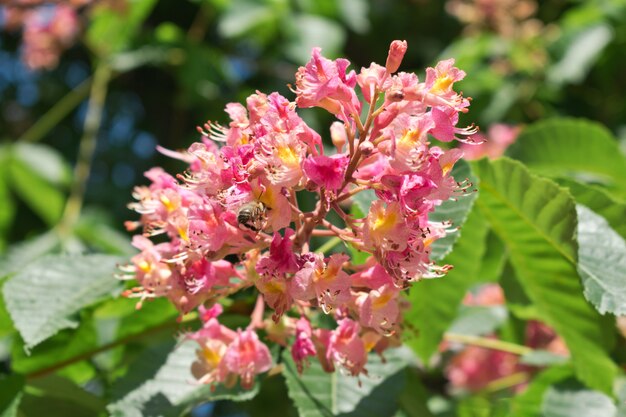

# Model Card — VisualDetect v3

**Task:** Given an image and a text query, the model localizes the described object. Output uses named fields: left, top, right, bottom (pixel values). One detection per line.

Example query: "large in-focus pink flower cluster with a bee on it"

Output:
left=126, top=41, right=476, bottom=387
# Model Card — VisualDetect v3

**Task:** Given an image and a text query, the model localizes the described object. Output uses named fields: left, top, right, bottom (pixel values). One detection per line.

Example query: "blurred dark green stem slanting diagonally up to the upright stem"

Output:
left=18, top=78, right=92, bottom=142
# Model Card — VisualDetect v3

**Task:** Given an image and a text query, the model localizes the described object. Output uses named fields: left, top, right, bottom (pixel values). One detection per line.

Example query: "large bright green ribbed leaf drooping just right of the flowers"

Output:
left=474, top=158, right=617, bottom=393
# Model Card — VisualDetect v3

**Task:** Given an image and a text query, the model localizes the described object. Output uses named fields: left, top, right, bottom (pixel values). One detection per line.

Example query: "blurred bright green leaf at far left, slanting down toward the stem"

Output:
left=9, top=159, right=65, bottom=226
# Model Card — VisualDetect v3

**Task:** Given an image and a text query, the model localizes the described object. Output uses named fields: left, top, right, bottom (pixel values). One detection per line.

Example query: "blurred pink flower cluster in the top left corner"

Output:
left=2, top=0, right=91, bottom=69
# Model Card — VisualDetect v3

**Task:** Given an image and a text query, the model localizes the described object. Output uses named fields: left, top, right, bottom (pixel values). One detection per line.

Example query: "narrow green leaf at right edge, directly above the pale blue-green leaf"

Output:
left=556, top=178, right=626, bottom=239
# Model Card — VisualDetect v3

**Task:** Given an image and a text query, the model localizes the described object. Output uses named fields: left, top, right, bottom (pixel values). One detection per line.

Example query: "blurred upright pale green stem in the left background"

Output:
left=58, top=62, right=111, bottom=236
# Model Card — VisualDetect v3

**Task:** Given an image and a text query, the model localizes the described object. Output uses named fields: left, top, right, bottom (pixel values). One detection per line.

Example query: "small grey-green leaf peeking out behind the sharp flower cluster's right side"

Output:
left=428, top=160, right=478, bottom=261
